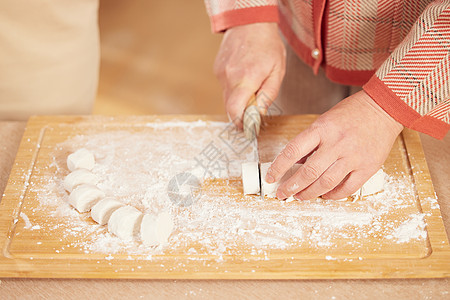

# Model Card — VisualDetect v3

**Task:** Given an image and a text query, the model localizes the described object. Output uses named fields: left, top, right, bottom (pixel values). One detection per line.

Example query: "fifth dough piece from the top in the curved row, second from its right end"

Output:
left=108, top=205, right=144, bottom=241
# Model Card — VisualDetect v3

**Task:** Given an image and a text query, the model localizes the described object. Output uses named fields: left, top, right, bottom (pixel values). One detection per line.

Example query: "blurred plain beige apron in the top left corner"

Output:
left=0, top=0, right=99, bottom=120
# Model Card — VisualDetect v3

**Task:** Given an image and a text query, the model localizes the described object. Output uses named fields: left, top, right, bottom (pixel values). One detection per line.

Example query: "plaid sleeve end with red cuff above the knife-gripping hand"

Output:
left=205, top=0, right=278, bottom=32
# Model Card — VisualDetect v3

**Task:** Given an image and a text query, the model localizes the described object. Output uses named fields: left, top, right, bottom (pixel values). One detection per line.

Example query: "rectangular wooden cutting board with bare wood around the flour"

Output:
left=0, top=115, right=450, bottom=279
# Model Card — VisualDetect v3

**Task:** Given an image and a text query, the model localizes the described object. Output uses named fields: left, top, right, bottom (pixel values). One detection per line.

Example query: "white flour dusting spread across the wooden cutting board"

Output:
left=22, top=121, right=427, bottom=261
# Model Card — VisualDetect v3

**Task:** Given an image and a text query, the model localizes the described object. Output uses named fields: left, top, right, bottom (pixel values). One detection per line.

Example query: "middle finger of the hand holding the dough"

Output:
left=277, top=147, right=342, bottom=199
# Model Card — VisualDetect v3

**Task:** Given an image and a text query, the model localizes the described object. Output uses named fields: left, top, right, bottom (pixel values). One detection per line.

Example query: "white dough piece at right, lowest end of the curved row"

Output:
left=141, top=212, right=174, bottom=246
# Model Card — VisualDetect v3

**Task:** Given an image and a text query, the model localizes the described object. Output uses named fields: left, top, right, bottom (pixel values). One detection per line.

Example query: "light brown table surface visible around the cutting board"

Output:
left=0, top=122, right=450, bottom=299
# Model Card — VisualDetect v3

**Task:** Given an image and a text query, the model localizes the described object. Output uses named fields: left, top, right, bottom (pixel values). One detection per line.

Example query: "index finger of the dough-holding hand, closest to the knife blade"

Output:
left=266, top=129, right=320, bottom=184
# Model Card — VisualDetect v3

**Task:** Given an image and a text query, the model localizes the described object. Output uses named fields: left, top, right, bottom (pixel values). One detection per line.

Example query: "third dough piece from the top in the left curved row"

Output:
left=69, top=184, right=105, bottom=213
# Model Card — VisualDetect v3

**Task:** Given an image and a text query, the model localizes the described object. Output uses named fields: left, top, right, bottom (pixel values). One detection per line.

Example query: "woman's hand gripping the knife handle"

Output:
left=214, top=23, right=286, bottom=128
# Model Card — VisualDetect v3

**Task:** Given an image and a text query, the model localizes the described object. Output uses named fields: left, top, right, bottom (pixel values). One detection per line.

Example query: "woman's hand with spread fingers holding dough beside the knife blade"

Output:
left=266, top=91, right=403, bottom=200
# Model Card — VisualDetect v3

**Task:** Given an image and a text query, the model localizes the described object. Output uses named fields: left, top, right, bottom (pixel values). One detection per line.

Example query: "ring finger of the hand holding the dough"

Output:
left=295, top=159, right=350, bottom=200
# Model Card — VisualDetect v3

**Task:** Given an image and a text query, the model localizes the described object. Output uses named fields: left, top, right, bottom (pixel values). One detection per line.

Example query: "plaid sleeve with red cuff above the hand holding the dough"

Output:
left=363, top=0, right=450, bottom=139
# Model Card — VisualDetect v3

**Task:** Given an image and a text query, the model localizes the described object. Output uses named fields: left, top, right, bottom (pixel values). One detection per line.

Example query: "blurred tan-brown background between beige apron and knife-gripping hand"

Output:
left=94, top=0, right=225, bottom=115
